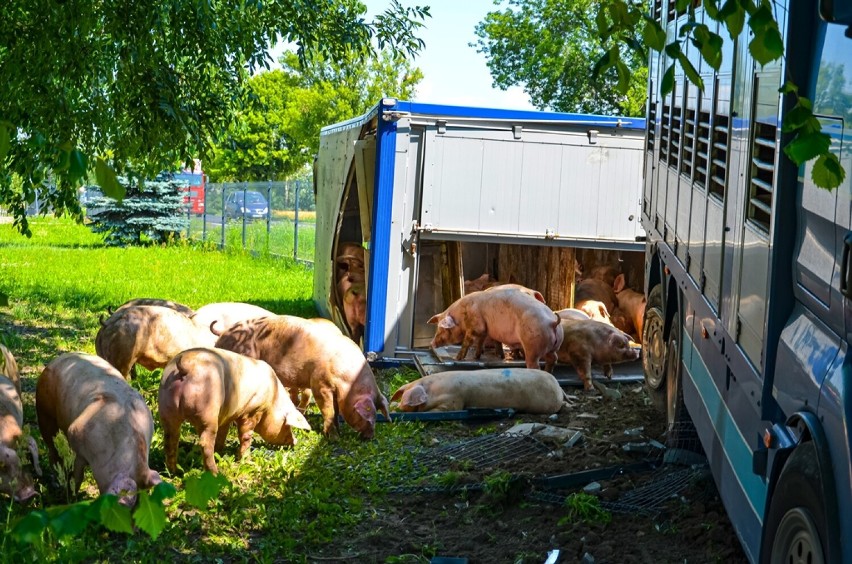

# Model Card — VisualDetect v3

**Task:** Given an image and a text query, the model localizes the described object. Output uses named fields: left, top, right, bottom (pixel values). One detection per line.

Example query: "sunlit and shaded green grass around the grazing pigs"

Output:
left=0, top=218, right=422, bottom=562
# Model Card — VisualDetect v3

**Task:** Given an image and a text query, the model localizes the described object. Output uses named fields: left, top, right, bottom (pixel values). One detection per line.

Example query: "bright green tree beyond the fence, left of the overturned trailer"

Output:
left=207, top=51, right=423, bottom=182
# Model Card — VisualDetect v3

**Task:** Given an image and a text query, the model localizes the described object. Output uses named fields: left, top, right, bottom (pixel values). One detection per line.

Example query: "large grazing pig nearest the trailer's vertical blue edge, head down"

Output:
left=216, top=315, right=390, bottom=439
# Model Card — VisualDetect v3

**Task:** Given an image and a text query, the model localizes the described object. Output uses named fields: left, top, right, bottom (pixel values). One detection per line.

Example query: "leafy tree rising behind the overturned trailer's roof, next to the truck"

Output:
left=476, top=0, right=648, bottom=116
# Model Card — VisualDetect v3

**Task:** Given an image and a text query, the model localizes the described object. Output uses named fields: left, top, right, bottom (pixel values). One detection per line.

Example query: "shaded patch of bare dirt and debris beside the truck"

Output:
left=316, top=383, right=747, bottom=564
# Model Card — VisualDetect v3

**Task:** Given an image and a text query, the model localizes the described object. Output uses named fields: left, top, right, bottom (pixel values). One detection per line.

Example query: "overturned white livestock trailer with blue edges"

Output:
left=313, top=98, right=645, bottom=366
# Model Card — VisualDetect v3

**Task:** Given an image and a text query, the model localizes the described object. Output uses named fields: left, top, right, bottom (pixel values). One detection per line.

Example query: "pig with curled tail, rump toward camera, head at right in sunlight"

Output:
left=159, top=346, right=311, bottom=474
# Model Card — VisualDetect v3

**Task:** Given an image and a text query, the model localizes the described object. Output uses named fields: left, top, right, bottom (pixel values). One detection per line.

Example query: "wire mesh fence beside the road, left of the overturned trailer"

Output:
left=186, top=180, right=316, bottom=264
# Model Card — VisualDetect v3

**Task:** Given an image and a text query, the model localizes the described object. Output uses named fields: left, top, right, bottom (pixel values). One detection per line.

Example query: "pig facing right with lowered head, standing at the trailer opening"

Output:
left=557, top=318, right=639, bottom=390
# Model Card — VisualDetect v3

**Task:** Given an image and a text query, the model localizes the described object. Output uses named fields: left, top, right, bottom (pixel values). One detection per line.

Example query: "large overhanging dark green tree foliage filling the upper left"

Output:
left=0, top=0, right=429, bottom=233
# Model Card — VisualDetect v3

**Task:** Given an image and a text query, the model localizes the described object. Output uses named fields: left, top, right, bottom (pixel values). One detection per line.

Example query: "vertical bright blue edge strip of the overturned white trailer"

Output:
left=364, top=104, right=396, bottom=352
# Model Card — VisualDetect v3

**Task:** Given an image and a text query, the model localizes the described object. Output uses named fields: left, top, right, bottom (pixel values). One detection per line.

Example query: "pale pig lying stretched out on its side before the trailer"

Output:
left=391, top=368, right=566, bottom=414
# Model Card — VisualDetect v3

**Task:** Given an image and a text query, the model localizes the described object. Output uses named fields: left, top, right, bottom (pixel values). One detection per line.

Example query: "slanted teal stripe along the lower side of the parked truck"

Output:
left=683, top=331, right=767, bottom=524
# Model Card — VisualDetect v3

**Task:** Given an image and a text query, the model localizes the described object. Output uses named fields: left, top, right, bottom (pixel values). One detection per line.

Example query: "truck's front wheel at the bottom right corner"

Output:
left=760, top=441, right=836, bottom=564
